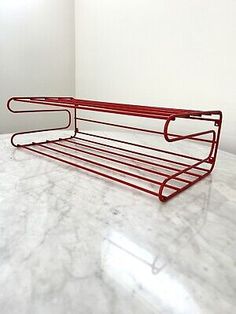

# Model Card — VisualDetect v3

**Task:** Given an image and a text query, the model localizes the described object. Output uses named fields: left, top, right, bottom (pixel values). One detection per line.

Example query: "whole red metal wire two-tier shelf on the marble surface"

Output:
left=7, top=97, right=222, bottom=201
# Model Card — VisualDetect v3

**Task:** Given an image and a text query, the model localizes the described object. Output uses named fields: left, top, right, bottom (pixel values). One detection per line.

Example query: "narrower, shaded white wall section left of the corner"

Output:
left=0, top=0, right=75, bottom=133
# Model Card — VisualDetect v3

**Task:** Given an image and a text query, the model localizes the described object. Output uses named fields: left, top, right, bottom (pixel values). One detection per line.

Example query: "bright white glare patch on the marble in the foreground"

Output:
left=102, top=232, right=199, bottom=313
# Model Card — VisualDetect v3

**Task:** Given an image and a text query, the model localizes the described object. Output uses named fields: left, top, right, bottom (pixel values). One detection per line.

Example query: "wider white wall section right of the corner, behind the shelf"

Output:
left=76, top=0, right=236, bottom=153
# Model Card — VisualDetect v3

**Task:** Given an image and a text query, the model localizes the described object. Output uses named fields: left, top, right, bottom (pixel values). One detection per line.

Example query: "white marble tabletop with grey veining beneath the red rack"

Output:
left=0, top=135, right=236, bottom=314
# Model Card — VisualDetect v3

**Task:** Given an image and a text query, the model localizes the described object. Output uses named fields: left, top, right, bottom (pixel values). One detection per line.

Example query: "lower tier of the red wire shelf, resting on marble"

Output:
left=17, top=132, right=211, bottom=201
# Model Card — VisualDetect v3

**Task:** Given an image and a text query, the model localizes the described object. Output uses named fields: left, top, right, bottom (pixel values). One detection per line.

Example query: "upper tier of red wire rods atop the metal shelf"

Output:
left=11, top=97, right=218, bottom=120
